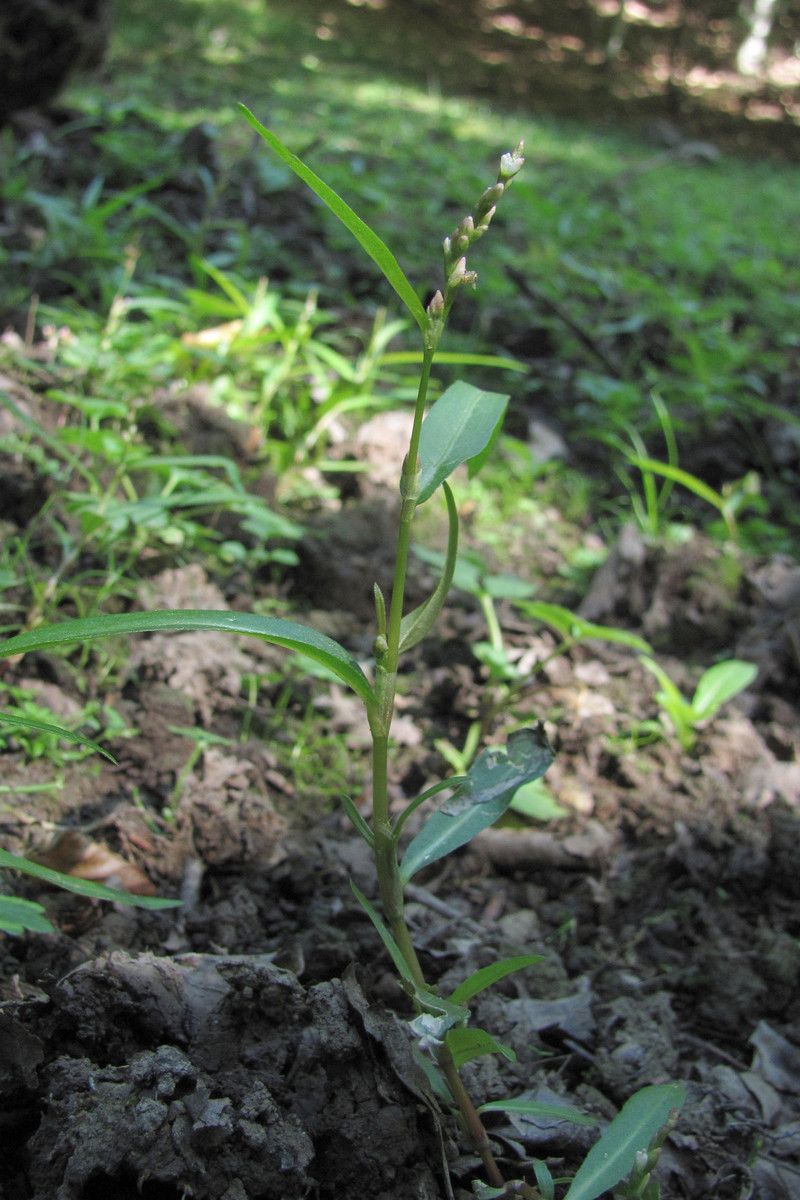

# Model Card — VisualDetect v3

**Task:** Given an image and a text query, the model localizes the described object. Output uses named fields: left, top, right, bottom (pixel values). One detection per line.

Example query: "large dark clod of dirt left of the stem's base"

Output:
left=6, top=952, right=437, bottom=1200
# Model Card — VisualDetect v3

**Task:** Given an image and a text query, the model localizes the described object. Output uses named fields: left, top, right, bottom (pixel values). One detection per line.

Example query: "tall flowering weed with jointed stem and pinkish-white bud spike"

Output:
left=0, top=124, right=684, bottom=1200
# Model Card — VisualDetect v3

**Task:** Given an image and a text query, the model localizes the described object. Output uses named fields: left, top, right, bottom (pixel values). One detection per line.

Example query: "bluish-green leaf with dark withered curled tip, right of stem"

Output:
left=401, top=726, right=554, bottom=883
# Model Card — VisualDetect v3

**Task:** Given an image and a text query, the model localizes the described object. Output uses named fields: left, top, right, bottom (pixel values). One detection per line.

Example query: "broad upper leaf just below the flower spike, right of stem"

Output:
left=417, top=380, right=509, bottom=504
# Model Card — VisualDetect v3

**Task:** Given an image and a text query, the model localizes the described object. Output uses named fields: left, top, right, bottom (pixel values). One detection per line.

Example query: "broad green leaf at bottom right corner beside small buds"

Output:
left=564, top=1084, right=686, bottom=1200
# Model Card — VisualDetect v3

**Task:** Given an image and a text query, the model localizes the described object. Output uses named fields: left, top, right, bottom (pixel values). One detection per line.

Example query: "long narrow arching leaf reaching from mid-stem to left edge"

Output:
left=0, top=608, right=374, bottom=704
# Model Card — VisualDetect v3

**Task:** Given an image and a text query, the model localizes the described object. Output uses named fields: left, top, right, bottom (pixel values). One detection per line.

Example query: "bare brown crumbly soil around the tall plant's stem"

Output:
left=0, top=386, right=800, bottom=1200
